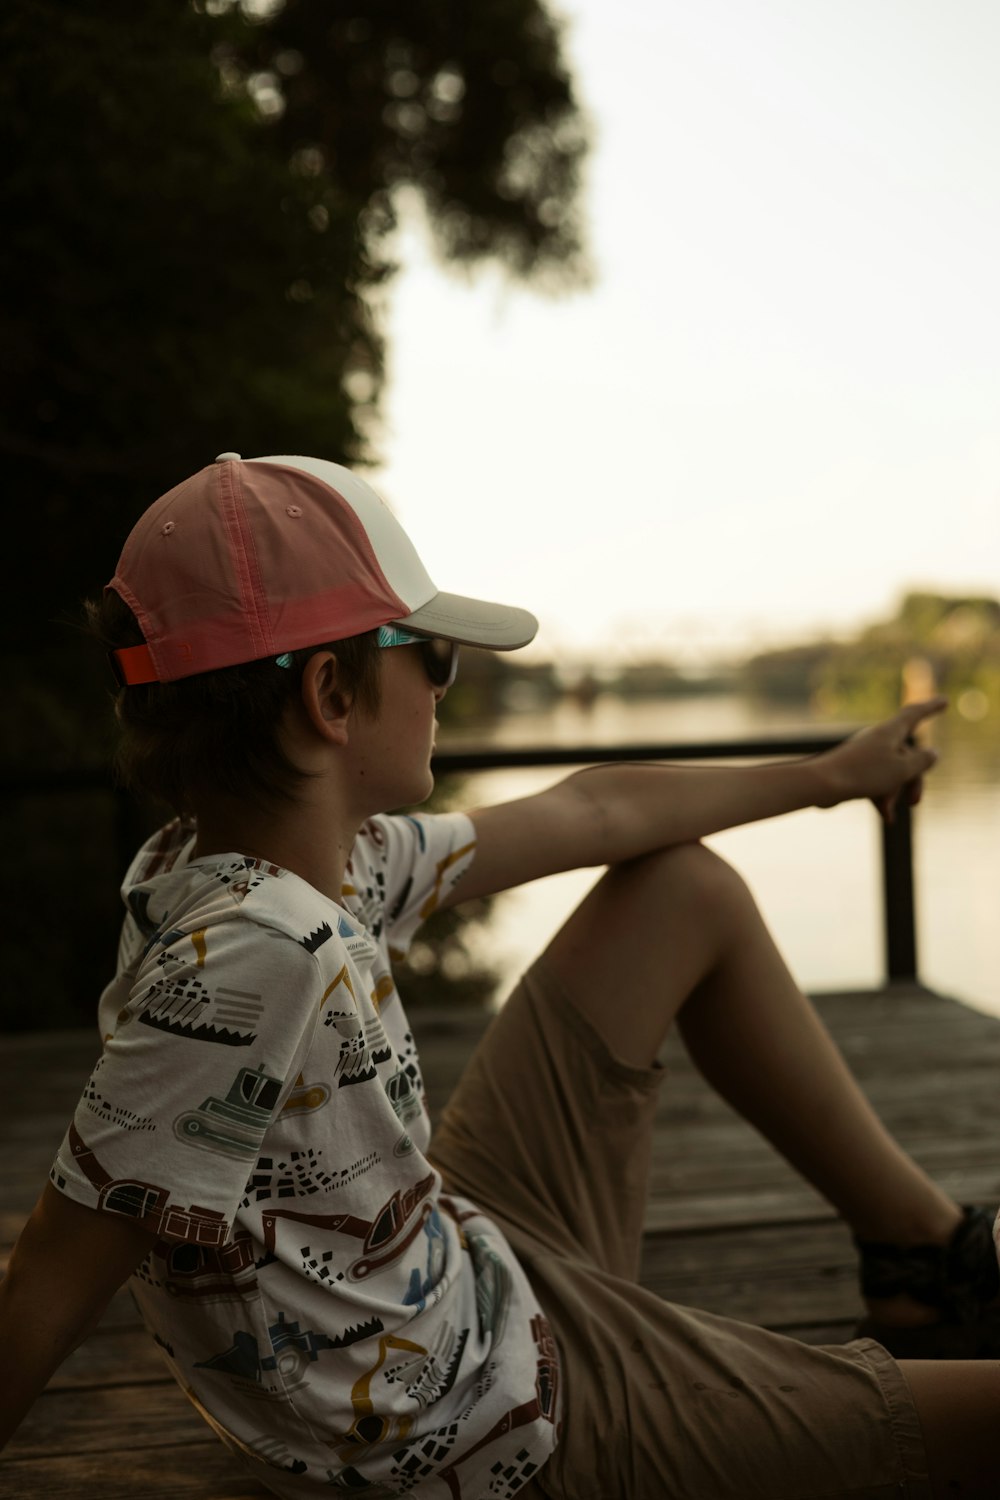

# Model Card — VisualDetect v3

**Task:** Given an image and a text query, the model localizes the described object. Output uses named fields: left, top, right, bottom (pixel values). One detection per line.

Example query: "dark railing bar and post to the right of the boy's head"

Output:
left=432, top=732, right=918, bottom=984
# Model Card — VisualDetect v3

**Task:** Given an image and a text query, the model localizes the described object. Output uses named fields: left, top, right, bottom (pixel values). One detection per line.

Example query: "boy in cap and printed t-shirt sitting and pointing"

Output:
left=0, top=453, right=1000, bottom=1500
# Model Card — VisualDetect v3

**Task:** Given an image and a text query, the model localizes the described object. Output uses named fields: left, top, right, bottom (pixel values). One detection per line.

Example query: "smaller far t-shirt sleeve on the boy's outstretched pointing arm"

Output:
left=372, top=813, right=475, bottom=957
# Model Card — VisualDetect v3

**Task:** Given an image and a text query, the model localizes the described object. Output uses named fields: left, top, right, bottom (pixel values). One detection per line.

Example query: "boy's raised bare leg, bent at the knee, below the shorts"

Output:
left=546, top=845, right=961, bottom=1284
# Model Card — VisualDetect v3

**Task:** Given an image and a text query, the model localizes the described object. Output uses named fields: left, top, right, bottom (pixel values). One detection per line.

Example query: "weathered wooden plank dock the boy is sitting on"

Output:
left=0, top=986, right=1000, bottom=1500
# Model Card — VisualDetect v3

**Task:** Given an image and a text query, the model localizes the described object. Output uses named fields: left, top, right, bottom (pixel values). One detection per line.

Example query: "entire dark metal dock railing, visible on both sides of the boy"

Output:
left=0, top=732, right=918, bottom=984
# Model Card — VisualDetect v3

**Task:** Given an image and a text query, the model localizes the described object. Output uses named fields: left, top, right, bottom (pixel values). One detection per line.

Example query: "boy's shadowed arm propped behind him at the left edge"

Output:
left=0, top=1184, right=157, bottom=1448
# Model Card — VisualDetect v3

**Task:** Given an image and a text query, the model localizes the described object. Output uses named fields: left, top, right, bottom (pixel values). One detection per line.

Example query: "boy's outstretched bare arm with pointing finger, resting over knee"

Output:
left=444, top=698, right=948, bottom=906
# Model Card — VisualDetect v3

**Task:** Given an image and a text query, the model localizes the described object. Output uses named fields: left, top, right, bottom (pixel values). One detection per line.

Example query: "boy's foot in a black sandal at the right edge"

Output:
left=855, top=1208, right=1000, bottom=1359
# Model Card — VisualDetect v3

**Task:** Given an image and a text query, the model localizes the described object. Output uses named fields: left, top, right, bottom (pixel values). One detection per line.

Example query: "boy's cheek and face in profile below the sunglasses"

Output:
left=348, top=645, right=445, bottom=816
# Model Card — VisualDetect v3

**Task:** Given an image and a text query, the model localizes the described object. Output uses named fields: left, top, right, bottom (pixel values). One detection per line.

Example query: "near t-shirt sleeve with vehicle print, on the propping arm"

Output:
left=51, top=918, right=322, bottom=1245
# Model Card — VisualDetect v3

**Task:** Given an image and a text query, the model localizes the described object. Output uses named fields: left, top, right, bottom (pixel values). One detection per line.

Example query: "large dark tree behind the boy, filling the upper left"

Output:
left=0, top=0, right=586, bottom=1025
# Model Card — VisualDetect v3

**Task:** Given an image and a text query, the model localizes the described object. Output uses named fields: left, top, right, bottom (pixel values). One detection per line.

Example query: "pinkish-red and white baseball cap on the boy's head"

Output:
left=108, top=453, right=538, bottom=684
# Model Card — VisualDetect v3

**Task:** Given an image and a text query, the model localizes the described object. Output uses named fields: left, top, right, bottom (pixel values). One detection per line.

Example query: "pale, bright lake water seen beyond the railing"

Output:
left=441, top=695, right=1000, bottom=1016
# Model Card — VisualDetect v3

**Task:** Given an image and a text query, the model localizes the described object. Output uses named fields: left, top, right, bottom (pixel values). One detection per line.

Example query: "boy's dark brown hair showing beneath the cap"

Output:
left=84, top=590, right=379, bottom=816
